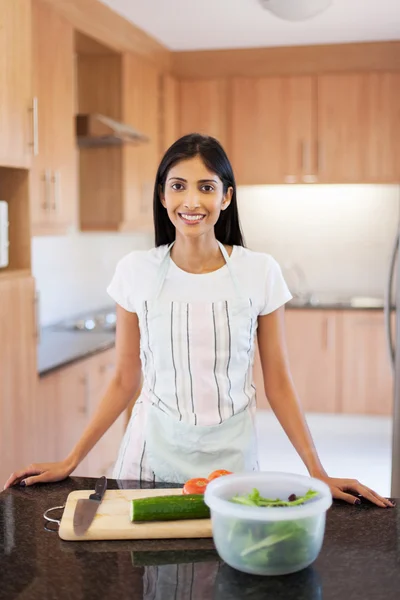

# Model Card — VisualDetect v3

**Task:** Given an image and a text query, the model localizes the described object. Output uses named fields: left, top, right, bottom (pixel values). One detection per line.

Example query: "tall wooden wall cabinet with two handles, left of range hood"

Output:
left=31, top=0, right=77, bottom=235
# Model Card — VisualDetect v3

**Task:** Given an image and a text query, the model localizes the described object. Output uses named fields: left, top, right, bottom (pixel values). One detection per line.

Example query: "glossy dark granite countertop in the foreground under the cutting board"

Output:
left=0, top=478, right=400, bottom=600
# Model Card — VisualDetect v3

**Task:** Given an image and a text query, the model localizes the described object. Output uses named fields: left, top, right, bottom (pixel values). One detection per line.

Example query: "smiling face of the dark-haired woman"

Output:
left=160, top=156, right=233, bottom=237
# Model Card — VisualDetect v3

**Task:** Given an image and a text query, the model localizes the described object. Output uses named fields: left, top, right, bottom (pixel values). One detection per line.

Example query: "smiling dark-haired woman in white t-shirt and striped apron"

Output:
left=6, top=134, right=392, bottom=507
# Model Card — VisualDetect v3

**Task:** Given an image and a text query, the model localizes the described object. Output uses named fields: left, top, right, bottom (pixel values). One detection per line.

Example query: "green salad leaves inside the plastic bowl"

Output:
left=225, top=489, right=319, bottom=570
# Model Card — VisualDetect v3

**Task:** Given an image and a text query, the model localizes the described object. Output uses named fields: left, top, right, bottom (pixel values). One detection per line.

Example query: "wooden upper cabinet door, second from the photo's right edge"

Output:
left=318, top=74, right=368, bottom=183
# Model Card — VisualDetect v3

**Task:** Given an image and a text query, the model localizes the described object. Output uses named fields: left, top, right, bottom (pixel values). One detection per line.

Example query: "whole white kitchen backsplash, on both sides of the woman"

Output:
left=32, top=185, right=400, bottom=325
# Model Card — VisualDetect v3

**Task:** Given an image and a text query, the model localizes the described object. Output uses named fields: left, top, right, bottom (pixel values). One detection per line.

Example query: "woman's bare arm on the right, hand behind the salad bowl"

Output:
left=258, top=308, right=391, bottom=507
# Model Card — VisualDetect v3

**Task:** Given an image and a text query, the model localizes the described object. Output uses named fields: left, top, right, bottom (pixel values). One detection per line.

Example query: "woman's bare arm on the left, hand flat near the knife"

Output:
left=4, top=306, right=141, bottom=489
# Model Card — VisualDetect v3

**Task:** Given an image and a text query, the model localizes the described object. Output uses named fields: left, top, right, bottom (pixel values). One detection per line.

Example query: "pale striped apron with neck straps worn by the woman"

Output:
left=113, top=243, right=258, bottom=483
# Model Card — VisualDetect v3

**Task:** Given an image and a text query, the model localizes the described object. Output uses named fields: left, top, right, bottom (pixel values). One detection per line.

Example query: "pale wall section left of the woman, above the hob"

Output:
left=32, top=233, right=153, bottom=325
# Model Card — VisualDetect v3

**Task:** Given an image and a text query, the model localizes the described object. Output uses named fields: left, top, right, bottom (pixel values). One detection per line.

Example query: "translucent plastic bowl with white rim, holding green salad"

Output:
left=204, top=472, right=332, bottom=575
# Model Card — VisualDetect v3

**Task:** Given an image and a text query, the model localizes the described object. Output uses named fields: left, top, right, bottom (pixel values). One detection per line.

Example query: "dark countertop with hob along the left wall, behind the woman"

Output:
left=37, top=327, right=115, bottom=377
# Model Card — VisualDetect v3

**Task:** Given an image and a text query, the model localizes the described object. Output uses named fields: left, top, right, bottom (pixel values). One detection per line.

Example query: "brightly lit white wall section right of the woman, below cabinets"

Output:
left=238, top=185, right=400, bottom=299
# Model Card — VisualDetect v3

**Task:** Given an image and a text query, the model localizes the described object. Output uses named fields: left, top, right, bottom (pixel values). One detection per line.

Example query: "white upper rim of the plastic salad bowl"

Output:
left=204, top=471, right=332, bottom=521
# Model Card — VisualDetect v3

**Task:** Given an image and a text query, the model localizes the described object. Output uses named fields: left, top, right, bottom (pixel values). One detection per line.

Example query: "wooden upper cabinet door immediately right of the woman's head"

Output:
left=230, top=78, right=286, bottom=185
